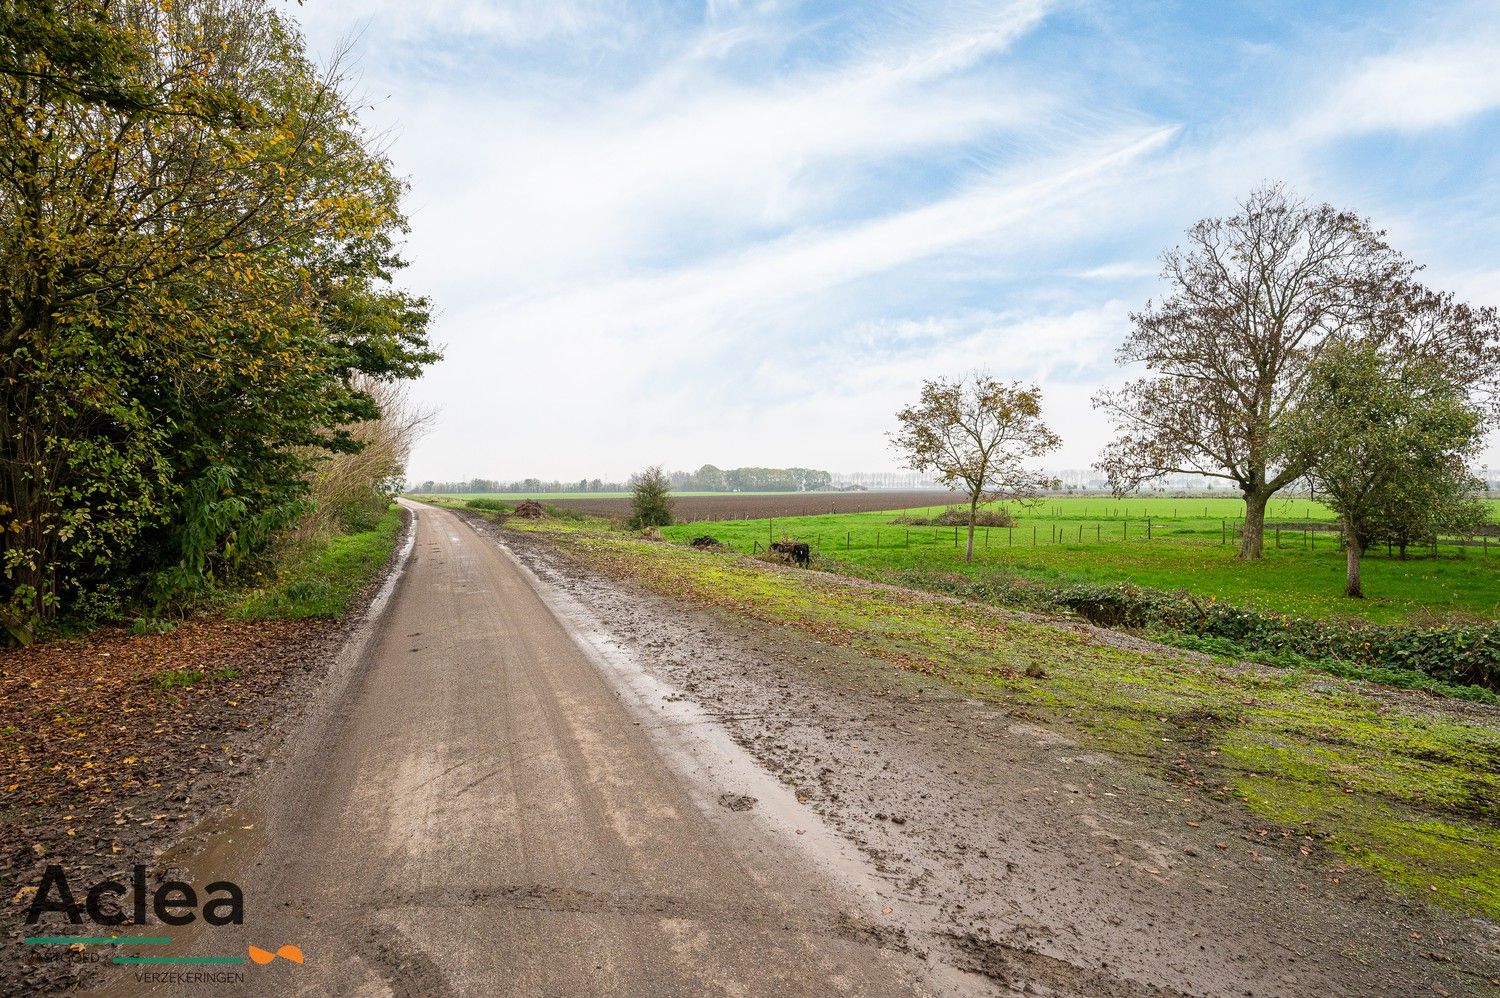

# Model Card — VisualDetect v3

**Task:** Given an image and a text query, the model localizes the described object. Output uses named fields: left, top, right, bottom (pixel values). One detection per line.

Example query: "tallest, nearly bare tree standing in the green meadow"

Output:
left=1094, top=186, right=1416, bottom=558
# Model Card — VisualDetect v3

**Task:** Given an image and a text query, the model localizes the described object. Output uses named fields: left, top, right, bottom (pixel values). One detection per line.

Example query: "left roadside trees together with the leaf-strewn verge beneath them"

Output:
left=0, top=0, right=437, bottom=966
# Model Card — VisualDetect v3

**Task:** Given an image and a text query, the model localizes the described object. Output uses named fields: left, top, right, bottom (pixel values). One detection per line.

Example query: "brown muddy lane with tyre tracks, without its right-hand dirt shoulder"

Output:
left=113, top=504, right=948, bottom=995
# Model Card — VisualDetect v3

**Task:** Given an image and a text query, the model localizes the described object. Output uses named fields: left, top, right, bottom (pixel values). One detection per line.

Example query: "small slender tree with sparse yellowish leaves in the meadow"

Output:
left=891, top=374, right=1062, bottom=561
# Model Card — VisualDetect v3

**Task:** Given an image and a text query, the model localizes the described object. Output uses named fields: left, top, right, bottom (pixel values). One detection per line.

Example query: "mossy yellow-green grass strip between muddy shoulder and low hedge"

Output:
left=453, top=503, right=1500, bottom=918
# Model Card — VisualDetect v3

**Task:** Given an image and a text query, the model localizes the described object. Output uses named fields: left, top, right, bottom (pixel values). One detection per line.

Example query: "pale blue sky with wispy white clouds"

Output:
left=276, top=0, right=1500, bottom=480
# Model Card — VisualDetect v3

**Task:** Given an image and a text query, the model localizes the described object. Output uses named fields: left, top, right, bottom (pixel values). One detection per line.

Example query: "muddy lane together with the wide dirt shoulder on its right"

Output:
left=90, top=506, right=1500, bottom=998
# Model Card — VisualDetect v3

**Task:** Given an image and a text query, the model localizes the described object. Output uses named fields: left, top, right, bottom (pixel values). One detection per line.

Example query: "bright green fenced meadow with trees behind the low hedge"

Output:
left=663, top=497, right=1500, bottom=621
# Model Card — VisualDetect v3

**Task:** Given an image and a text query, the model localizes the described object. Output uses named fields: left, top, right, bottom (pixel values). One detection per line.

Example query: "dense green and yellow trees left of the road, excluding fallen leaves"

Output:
left=0, top=0, right=438, bottom=644
